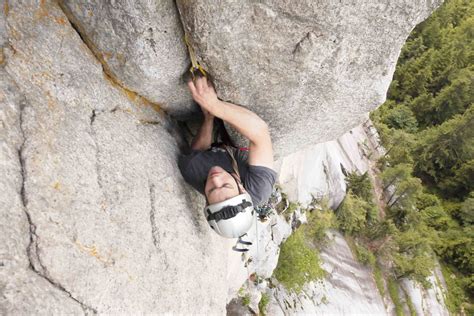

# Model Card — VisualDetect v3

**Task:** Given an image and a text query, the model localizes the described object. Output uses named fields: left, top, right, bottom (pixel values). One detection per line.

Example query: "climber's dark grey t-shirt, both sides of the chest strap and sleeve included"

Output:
left=178, top=147, right=277, bottom=206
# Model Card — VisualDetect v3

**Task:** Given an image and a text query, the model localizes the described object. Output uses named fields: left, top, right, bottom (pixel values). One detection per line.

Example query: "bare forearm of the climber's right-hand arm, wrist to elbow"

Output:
left=207, top=100, right=268, bottom=144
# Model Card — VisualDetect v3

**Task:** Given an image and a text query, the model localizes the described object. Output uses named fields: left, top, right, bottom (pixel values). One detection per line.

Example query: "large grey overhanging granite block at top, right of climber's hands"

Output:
left=177, top=0, right=441, bottom=157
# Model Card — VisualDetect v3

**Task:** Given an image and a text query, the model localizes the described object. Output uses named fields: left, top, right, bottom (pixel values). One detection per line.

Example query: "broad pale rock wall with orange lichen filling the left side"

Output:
left=0, top=1, right=230, bottom=314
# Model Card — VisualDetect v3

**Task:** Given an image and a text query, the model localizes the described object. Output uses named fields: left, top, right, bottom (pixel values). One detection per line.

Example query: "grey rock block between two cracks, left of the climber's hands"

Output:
left=60, top=0, right=197, bottom=116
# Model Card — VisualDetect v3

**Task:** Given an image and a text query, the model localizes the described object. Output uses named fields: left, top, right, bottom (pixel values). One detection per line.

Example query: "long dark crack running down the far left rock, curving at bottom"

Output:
left=18, top=101, right=97, bottom=314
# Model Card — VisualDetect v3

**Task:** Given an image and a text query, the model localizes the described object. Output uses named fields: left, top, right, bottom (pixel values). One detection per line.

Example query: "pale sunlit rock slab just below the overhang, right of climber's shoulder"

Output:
left=278, top=120, right=378, bottom=209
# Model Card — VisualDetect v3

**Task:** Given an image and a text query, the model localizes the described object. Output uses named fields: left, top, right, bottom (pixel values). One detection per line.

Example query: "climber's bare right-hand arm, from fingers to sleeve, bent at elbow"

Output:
left=188, top=78, right=273, bottom=168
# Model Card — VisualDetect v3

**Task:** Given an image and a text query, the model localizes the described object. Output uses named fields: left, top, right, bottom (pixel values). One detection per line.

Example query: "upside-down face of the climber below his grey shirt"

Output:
left=204, top=166, right=243, bottom=204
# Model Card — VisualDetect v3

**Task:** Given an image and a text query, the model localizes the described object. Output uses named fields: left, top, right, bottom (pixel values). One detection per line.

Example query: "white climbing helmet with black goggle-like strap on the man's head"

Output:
left=204, top=192, right=255, bottom=238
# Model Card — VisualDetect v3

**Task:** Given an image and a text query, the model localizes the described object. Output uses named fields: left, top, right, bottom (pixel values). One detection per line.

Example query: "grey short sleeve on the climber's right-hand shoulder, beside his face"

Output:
left=243, top=165, right=277, bottom=206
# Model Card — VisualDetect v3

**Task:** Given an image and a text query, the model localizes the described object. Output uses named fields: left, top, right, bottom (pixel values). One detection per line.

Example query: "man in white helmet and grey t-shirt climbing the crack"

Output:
left=179, top=76, right=277, bottom=238
